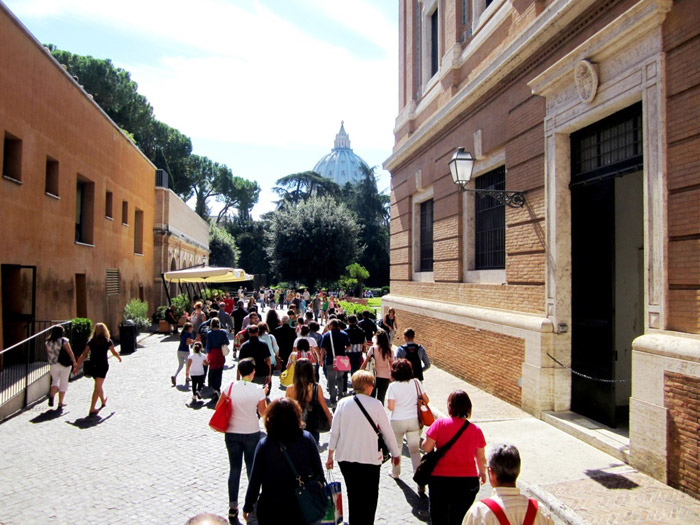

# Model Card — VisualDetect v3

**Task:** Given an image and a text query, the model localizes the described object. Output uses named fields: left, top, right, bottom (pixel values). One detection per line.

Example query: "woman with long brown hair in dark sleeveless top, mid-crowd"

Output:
left=284, top=357, right=333, bottom=444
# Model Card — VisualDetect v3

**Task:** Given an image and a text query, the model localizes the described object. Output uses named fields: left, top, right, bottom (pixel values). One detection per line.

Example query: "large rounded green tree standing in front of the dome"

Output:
left=267, top=196, right=359, bottom=286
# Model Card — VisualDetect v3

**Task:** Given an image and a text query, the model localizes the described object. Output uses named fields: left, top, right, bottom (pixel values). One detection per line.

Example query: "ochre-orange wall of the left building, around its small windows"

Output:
left=0, top=5, right=154, bottom=331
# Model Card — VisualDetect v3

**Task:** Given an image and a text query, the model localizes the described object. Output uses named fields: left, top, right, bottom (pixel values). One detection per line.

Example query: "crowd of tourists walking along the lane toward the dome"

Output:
left=46, top=290, right=551, bottom=525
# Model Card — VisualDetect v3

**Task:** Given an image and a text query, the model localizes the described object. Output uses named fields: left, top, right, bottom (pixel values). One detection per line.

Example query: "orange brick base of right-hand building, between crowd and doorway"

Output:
left=394, top=309, right=525, bottom=410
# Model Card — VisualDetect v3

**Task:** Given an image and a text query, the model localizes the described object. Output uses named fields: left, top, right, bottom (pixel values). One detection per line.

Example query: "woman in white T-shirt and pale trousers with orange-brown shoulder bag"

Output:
left=386, top=359, right=429, bottom=494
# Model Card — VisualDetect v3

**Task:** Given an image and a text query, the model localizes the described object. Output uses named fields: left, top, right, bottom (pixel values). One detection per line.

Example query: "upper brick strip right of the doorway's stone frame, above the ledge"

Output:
left=664, top=0, right=700, bottom=334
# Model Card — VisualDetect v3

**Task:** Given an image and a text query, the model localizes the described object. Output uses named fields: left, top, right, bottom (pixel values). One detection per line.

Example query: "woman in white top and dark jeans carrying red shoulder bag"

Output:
left=219, top=358, right=269, bottom=523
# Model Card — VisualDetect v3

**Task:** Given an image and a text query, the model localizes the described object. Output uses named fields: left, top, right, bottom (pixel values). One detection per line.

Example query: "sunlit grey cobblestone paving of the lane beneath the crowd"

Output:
left=0, top=335, right=454, bottom=525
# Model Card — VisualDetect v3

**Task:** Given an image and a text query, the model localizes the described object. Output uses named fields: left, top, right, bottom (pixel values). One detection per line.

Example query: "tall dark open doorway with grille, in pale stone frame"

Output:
left=571, top=104, right=644, bottom=427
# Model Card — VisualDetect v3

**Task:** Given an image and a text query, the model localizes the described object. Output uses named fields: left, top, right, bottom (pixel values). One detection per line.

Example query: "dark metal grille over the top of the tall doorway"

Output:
left=571, top=104, right=644, bottom=183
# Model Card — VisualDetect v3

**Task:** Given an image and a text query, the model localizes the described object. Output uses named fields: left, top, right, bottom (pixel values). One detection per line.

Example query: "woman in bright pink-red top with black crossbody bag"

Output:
left=423, top=390, right=486, bottom=525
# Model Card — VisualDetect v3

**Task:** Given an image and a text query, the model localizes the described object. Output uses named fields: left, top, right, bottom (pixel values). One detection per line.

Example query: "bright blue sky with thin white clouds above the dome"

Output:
left=2, top=0, right=398, bottom=217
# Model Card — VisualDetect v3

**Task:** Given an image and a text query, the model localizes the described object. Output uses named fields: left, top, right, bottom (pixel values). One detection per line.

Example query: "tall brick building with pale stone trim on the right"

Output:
left=383, top=0, right=700, bottom=496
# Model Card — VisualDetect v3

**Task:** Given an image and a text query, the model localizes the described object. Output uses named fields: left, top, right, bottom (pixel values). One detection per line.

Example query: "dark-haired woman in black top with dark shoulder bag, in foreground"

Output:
left=243, top=397, right=323, bottom=525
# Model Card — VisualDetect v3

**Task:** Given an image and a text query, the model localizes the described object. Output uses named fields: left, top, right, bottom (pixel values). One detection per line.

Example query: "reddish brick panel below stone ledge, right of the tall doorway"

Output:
left=664, top=371, right=700, bottom=498
